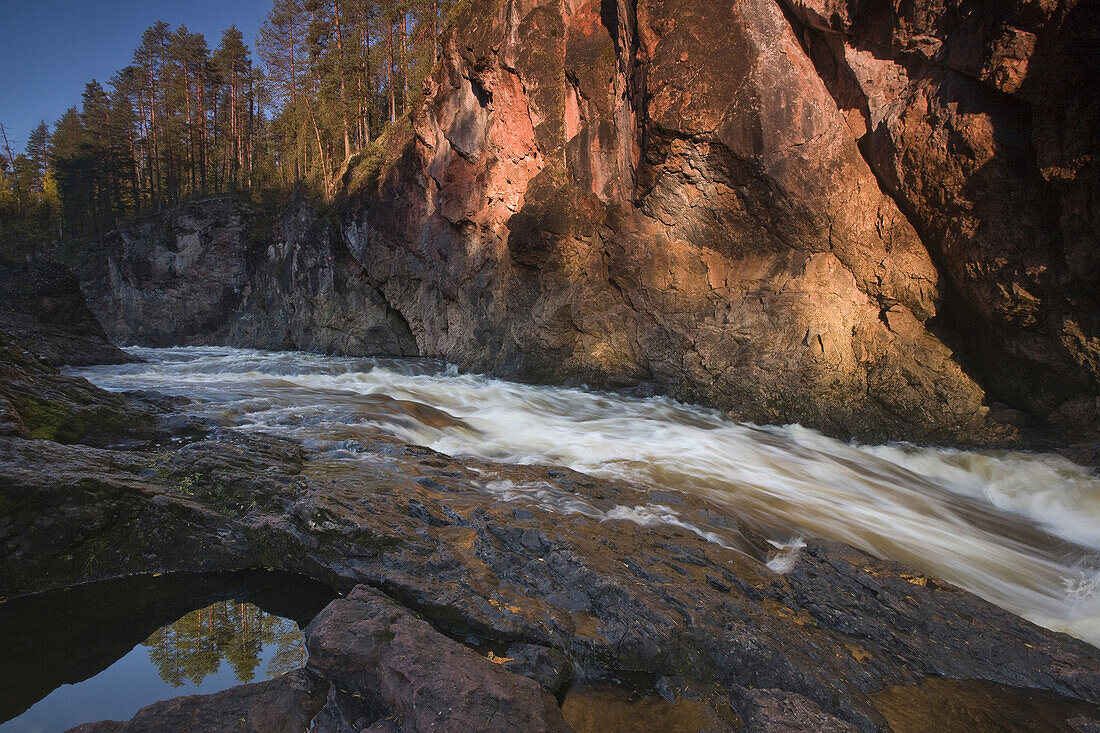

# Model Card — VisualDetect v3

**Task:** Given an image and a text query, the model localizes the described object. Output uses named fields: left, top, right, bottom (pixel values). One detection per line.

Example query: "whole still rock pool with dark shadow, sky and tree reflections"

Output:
left=0, top=572, right=334, bottom=733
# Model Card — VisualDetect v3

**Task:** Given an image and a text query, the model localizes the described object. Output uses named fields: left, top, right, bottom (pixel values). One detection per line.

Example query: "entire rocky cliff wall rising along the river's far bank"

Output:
left=70, top=0, right=1100, bottom=445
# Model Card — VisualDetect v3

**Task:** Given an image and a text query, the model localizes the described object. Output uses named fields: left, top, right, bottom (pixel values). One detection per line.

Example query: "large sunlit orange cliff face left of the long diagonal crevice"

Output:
left=340, top=0, right=1012, bottom=442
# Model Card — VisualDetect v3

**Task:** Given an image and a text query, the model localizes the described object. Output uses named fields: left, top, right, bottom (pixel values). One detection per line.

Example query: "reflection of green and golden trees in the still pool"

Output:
left=143, top=601, right=306, bottom=687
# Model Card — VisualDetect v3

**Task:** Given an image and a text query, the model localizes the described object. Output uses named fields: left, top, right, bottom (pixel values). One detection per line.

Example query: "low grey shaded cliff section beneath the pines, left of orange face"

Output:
left=77, top=192, right=416, bottom=355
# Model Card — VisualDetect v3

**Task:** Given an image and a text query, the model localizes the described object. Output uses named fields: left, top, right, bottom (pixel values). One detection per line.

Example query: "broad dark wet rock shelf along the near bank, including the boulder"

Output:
left=0, top=338, right=1100, bottom=731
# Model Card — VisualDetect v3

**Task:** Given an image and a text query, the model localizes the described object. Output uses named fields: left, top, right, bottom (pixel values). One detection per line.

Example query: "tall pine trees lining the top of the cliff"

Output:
left=0, top=0, right=455, bottom=244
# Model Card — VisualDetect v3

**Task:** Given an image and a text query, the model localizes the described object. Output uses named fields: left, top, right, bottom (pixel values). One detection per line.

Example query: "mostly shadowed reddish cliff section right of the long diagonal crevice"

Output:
left=783, top=0, right=1100, bottom=433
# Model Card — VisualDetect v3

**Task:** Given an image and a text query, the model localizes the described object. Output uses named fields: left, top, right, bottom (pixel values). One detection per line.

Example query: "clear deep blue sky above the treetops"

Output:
left=0, top=0, right=271, bottom=153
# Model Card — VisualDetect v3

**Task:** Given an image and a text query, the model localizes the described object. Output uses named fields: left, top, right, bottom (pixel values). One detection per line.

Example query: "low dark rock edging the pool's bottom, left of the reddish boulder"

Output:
left=68, top=669, right=328, bottom=733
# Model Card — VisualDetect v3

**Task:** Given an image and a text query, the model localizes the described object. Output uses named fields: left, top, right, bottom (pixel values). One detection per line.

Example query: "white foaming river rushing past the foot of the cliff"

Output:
left=74, top=348, right=1100, bottom=646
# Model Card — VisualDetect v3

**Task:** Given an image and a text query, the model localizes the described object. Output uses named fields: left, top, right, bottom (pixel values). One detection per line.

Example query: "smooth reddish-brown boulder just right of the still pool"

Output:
left=306, top=586, right=569, bottom=731
